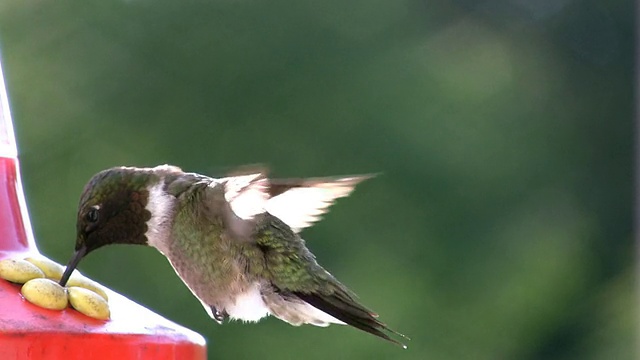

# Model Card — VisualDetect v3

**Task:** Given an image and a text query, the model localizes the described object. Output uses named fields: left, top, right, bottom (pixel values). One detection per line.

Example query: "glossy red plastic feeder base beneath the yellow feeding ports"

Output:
left=0, top=281, right=206, bottom=360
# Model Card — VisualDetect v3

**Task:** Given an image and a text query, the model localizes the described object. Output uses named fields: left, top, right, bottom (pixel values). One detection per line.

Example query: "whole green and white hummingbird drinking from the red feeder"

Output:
left=60, top=165, right=406, bottom=348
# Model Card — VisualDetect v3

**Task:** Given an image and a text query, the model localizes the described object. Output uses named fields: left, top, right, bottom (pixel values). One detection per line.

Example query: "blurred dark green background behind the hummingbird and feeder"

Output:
left=0, top=0, right=638, bottom=359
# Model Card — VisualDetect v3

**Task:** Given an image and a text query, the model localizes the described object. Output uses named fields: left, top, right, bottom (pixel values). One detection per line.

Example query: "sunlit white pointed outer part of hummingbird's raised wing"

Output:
left=265, top=175, right=373, bottom=232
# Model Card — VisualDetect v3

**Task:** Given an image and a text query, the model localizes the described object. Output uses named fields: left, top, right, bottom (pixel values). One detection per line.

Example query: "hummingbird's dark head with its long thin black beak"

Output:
left=60, top=167, right=160, bottom=286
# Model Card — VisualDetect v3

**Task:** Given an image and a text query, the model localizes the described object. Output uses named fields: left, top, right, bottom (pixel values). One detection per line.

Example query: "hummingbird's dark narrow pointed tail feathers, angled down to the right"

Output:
left=295, top=292, right=409, bottom=349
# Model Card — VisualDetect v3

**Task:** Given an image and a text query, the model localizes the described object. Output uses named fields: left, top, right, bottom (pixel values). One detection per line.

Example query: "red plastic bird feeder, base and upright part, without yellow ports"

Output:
left=0, top=63, right=206, bottom=360
